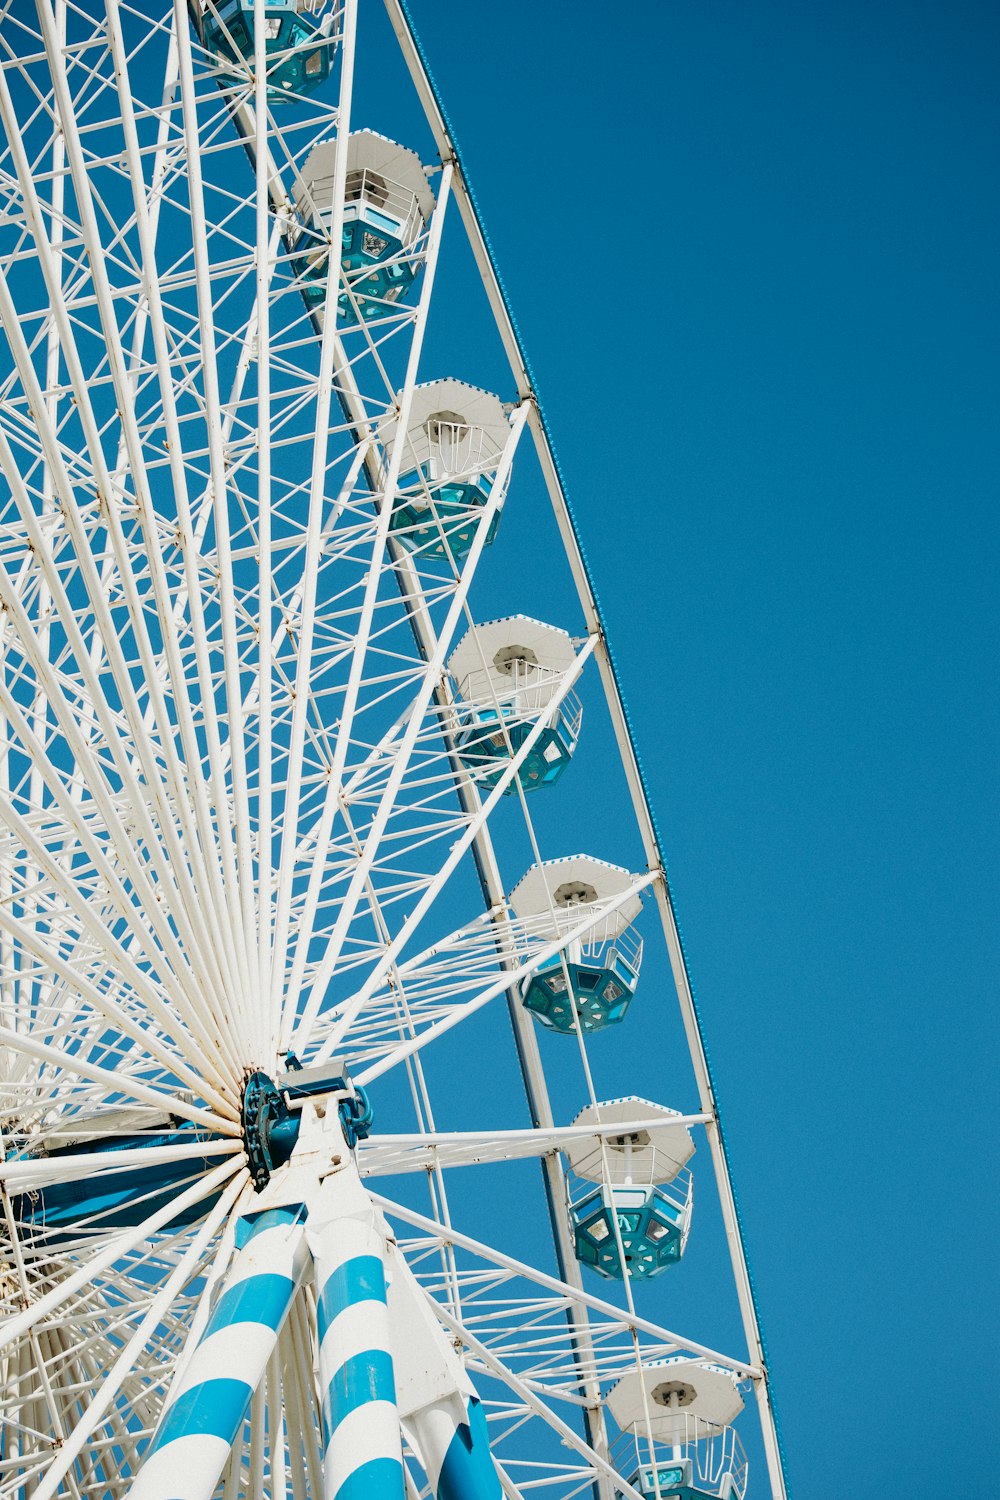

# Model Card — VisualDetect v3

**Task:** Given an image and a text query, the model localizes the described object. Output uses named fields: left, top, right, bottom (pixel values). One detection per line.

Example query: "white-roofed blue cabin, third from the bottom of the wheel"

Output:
left=510, top=855, right=642, bottom=1035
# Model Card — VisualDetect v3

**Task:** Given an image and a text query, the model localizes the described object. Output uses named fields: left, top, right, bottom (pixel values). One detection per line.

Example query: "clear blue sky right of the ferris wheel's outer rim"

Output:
left=392, top=0, right=1000, bottom=1500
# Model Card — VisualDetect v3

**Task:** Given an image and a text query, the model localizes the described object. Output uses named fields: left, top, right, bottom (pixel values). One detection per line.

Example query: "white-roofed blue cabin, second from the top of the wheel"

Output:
left=289, top=131, right=435, bottom=326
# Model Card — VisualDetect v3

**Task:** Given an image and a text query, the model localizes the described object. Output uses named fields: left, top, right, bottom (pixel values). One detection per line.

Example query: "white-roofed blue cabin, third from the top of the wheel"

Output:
left=381, top=380, right=510, bottom=560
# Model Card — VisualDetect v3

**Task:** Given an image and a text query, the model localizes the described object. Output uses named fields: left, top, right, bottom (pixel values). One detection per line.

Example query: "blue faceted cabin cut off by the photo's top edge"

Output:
left=202, top=0, right=337, bottom=104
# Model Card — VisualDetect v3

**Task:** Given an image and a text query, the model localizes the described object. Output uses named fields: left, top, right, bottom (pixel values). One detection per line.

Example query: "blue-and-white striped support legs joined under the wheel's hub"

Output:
left=122, top=1110, right=501, bottom=1500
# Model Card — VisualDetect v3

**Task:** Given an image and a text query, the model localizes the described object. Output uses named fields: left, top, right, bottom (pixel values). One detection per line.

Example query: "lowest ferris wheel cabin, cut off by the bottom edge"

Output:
left=606, top=1358, right=747, bottom=1500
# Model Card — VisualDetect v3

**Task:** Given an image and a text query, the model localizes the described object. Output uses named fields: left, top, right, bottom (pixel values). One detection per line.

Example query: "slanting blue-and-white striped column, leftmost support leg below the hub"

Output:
left=129, top=1205, right=309, bottom=1500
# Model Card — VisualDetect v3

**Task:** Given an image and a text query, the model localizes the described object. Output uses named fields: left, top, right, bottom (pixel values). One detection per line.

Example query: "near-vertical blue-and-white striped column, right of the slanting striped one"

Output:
left=309, top=1215, right=403, bottom=1500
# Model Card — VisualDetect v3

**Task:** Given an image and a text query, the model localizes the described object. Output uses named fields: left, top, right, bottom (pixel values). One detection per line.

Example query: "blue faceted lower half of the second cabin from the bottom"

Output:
left=570, top=1188, right=682, bottom=1281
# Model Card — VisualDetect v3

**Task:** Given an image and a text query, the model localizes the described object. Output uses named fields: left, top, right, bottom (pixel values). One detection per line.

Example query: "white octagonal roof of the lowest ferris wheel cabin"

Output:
left=607, top=1359, right=744, bottom=1443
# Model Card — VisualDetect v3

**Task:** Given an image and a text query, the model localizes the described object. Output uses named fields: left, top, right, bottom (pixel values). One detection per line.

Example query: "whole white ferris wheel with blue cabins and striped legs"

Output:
left=0, top=0, right=786, bottom=1500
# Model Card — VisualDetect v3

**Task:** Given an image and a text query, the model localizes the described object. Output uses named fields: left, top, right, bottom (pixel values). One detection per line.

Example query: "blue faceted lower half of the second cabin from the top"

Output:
left=291, top=207, right=420, bottom=326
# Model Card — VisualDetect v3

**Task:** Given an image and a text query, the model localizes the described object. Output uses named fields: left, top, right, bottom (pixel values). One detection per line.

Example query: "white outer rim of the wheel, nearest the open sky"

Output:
left=377, top=0, right=787, bottom=1500
